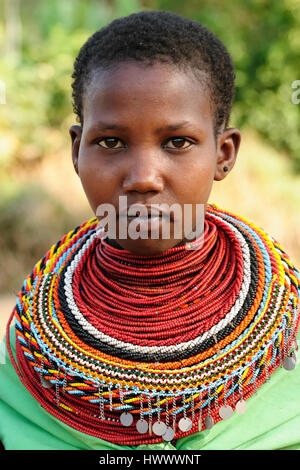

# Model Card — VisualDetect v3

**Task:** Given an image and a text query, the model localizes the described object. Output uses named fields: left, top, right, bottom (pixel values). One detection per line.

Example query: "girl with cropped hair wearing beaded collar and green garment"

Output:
left=0, top=11, right=300, bottom=450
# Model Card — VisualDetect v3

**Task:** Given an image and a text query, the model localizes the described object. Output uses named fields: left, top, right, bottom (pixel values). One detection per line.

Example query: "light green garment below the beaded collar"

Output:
left=0, top=330, right=300, bottom=450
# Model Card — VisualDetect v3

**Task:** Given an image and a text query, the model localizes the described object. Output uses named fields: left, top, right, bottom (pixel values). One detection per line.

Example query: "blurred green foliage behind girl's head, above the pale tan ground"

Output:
left=0, top=0, right=300, bottom=172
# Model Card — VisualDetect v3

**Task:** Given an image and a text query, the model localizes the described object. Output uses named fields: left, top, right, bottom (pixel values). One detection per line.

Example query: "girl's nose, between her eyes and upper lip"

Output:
left=123, top=151, right=164, bottom=193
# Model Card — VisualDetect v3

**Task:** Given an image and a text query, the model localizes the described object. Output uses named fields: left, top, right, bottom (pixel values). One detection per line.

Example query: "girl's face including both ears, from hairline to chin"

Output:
left=70, top=62, right=240, bottom=255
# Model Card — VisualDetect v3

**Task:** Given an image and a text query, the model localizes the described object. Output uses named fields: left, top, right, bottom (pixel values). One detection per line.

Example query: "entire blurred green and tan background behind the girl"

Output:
left=0, top=0, right=300, bottom=336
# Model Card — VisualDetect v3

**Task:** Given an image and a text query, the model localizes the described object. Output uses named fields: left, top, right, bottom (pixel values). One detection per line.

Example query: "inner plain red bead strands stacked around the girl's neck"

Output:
left=74, top=214, right=242, bottom=346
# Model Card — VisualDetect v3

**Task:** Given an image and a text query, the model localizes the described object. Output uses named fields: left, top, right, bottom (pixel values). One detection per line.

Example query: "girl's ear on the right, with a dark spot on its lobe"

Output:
left=214, top=128, right=241, bottom=181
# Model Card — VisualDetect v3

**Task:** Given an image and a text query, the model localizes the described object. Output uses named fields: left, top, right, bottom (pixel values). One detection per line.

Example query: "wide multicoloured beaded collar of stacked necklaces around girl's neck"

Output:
left=7, top=205, right=300, bottom=445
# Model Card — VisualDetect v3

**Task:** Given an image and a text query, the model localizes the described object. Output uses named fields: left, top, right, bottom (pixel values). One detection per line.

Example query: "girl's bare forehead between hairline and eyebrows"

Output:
left=83, top=62, right=212, bottom=126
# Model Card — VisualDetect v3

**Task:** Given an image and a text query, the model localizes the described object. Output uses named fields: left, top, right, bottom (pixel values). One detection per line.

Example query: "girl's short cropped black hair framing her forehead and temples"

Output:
left=72, top=10, right=235, bottom=134
